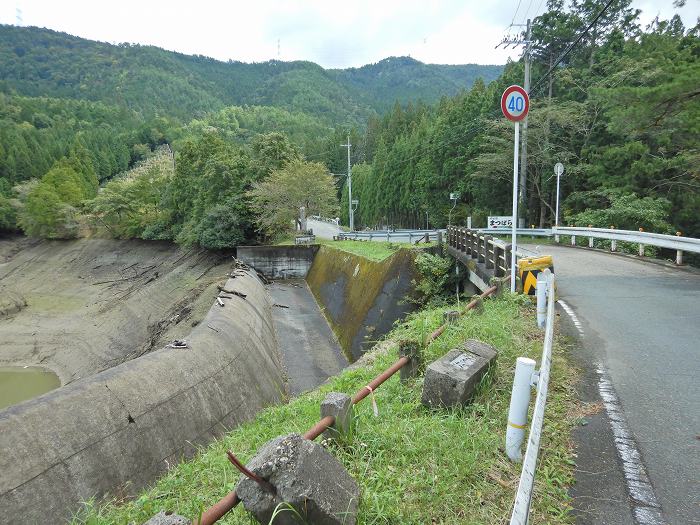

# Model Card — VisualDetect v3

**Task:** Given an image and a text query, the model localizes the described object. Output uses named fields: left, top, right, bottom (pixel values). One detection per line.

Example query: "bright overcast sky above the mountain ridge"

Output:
left=0, top=0, right=700, bottom=68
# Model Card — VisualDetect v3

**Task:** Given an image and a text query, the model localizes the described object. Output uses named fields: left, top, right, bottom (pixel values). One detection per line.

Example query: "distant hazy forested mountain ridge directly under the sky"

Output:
left=0, top=25, right=503, bottom=125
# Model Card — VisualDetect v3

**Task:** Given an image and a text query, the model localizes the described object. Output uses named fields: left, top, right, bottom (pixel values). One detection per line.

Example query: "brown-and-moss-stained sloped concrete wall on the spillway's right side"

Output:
left=306, top=246, right=418, bottom=360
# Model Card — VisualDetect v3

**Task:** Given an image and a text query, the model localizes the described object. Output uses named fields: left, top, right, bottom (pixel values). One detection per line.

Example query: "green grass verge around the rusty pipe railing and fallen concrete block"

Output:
left=73, top=292, right=577, bottom=525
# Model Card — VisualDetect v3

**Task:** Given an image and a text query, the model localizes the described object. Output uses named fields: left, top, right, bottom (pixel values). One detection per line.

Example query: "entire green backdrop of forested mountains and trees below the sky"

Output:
left=0, top=0, right=700, bottom=248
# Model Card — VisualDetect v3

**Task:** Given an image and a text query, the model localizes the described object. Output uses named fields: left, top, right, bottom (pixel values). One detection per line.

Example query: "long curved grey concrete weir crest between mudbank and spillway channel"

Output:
left=0, top=273, right=284, bottom=523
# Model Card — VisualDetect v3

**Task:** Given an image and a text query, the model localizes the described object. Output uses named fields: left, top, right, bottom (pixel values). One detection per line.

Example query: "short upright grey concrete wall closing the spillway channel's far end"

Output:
left=236, top=245, right=318, bottom=279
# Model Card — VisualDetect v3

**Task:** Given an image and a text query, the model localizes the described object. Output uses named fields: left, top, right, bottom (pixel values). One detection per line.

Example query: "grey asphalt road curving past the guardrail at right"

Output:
left=540, top=246, right=700, bottom=524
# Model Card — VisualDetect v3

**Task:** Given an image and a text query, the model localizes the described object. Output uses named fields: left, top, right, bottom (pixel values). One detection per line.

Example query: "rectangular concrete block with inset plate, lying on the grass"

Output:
left=421, top=339, right=498, bottom=408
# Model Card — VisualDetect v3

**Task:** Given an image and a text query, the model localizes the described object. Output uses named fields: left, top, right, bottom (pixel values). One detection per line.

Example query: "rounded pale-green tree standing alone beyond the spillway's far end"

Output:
left=248, top=160, right=338, bottom=236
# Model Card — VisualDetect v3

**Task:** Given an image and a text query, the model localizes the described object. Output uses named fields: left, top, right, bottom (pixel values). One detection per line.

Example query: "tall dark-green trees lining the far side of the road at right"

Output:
left=341, top=0, right=700, bottom=237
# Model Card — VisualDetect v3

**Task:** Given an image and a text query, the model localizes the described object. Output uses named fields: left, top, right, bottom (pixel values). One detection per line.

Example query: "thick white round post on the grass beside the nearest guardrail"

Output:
left=506, top=357, right=535, bottom=462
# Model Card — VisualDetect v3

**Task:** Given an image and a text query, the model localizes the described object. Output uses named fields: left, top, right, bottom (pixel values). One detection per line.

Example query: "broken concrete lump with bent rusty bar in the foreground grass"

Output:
left=236, top=434, right=360, bottom=525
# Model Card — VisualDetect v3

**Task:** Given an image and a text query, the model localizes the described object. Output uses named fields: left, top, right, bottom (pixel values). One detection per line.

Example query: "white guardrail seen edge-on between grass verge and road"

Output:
left=506, top=269, right=555, bottom=525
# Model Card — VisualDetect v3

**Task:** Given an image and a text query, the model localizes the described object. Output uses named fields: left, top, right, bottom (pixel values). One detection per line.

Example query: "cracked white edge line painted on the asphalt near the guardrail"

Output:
left=596, top=364, right=665, bottom=525
